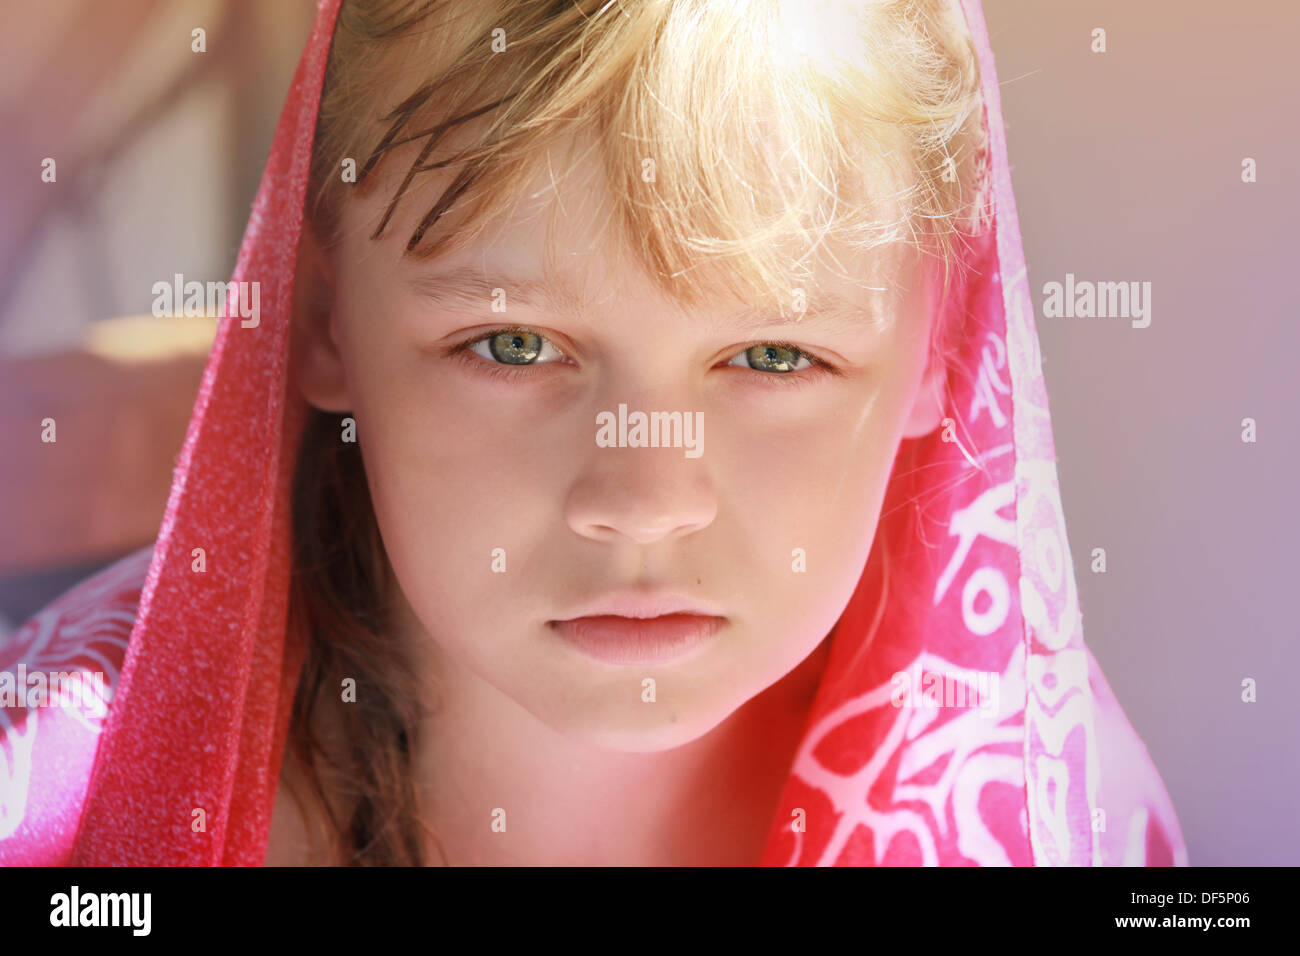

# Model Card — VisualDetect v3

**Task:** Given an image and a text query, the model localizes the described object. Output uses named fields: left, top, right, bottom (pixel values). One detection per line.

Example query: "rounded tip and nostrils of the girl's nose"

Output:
left=566, top=434, right=718, bottom=545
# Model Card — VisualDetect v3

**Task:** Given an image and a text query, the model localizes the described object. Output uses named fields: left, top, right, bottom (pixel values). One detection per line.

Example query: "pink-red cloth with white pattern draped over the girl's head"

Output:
left=0, top=0, right=1187, bottom=866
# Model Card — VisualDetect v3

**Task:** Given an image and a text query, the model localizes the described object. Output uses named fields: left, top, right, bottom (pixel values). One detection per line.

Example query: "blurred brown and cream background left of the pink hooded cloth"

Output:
left=0, top=0, right=315, bottom=621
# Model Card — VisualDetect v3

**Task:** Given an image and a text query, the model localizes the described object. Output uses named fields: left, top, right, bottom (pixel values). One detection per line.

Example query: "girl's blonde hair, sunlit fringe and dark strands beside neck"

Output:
left=295, top=0, right=989, bottom=862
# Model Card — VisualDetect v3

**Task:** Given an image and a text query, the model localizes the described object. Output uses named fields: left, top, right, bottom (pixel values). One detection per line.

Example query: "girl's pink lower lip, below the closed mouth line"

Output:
left=551, top=614, right=727, bottom=665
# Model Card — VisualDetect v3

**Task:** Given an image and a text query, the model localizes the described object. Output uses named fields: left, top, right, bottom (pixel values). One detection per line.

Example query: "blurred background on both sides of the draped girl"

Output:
left=0, top=0, right=1300, bottom=865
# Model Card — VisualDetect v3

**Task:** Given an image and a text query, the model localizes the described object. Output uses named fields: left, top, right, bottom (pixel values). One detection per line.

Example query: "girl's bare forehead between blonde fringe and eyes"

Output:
left=345, top=123, right=920, bottom=332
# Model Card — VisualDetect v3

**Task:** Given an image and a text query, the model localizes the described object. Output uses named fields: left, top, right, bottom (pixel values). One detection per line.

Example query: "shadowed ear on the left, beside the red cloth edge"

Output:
left=290, top=221, right=352, bottom=412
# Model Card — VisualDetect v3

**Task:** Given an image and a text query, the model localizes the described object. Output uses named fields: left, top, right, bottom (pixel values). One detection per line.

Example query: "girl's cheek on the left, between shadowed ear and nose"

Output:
left=350, top=342, right=575, bottom=644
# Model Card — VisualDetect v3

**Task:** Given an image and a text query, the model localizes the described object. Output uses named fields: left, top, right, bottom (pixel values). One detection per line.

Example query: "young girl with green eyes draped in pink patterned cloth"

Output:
left=0, top=0, right=1186, bottom=865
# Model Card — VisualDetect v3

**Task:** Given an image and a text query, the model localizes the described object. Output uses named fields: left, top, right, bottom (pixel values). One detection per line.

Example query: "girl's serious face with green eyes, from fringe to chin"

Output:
left=295, top=128, right=941, bottom=750
